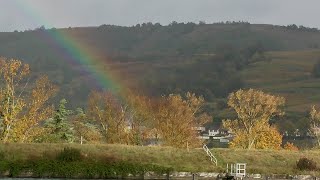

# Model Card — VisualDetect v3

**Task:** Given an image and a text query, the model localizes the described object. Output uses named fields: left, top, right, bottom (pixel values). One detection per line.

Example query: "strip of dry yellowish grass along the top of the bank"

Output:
left=0, top=144, right=320, bottom=174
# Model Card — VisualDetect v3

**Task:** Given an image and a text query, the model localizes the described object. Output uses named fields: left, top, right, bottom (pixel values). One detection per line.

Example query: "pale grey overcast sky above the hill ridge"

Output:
left=0, top=0, right=320, bottom=31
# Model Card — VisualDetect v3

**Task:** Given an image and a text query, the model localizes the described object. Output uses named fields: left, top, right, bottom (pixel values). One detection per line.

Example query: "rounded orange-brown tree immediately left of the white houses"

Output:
left=154, top=93, right=210, bottom=148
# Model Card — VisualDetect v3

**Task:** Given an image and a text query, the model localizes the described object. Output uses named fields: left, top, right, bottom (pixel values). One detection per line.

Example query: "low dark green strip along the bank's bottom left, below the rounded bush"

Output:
left=0, top=156, right=173, bottom=178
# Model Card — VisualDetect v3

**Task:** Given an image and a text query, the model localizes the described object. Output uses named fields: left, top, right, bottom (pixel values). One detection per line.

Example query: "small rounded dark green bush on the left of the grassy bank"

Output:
left=57, top=147, right=83, bottom=162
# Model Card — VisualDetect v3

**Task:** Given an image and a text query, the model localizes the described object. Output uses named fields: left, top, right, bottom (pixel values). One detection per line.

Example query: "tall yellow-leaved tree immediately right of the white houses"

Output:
left=223, top=89, right=285, bottom=149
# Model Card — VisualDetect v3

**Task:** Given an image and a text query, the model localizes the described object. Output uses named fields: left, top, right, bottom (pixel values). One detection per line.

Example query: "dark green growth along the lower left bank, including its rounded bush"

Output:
left=0, top=148, right=172, bottom=178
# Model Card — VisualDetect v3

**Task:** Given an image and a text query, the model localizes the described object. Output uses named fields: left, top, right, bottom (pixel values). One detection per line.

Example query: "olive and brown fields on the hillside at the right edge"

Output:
left=242, top=50, right=320, bottom=112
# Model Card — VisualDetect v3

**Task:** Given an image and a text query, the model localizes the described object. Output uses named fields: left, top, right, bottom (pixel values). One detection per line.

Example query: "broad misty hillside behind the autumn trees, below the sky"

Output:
left=0, top=22, right=320, bottom=134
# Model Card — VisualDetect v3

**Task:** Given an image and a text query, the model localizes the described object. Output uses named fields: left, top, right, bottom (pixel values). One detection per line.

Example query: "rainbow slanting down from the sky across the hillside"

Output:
left=12, top=0, right=125, bottom=93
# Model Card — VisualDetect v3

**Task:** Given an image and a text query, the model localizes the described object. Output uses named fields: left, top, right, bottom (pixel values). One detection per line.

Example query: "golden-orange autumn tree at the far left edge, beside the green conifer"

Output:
left=0, top=58, right=57, bottom=142
